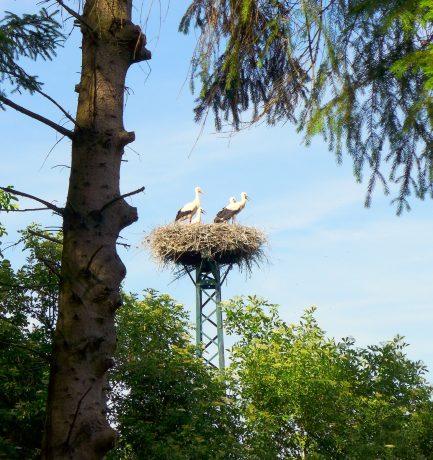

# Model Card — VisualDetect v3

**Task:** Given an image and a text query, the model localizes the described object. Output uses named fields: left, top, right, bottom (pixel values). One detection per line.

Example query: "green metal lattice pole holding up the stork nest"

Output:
left=188, top=259, right=231, bottom=370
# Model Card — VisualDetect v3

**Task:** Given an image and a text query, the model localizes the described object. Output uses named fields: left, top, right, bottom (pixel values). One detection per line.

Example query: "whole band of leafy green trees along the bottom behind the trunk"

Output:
left=0, top=232, right=433, bottom=460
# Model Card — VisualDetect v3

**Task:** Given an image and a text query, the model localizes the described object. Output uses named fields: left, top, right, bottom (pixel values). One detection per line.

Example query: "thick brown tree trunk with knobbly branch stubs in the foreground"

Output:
left=43, top=0, right=150, bottom=460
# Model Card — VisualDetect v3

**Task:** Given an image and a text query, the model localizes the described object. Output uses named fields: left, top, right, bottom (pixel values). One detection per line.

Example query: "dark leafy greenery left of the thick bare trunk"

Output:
left=0, top=226, right=61, bottom=460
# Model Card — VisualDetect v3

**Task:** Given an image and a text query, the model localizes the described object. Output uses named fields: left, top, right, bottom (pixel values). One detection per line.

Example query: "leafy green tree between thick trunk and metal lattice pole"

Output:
left=110, top=290, right=242, bottom=460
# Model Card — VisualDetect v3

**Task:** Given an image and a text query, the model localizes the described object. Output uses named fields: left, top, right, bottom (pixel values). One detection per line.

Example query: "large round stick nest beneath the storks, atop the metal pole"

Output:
left=146, top=223, right=267, bottom=272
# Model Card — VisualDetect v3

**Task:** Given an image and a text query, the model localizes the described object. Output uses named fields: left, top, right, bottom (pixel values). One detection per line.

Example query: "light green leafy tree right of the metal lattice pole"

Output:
left=226, top=297, right=433, bottom=460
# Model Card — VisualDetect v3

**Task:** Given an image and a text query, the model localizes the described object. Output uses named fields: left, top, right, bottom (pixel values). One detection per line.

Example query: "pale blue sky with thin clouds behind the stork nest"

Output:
left=0, top=0, right=433, bottom=378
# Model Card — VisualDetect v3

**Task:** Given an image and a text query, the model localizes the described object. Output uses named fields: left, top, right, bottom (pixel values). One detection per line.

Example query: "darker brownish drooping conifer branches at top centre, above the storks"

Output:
left=180, top=0, right=332, bottom=130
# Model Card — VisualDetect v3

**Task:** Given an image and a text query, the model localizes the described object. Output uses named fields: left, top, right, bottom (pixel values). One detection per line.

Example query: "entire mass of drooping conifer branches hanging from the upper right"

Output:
left=180, top=0, right=433, bottom=213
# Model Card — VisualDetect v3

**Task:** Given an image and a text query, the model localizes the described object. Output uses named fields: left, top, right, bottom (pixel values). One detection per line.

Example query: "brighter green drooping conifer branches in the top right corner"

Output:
left=303, top=0, right=433, bottom=214
